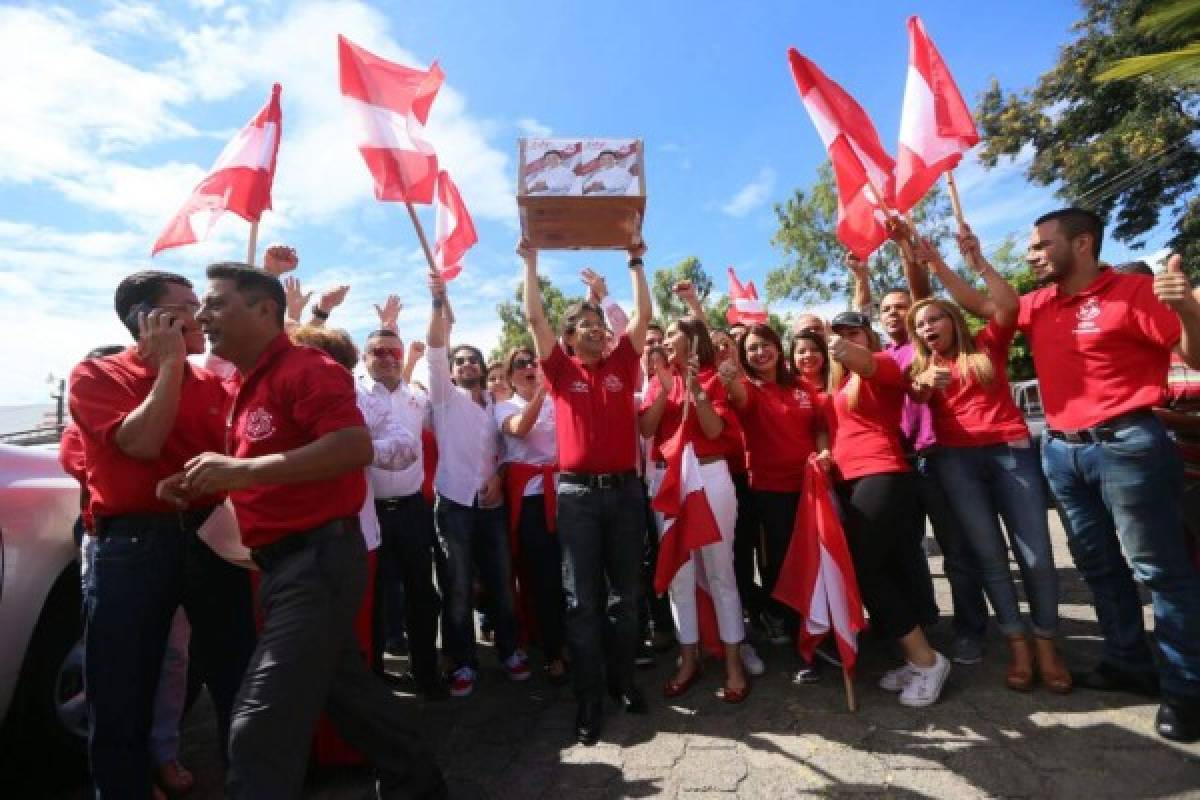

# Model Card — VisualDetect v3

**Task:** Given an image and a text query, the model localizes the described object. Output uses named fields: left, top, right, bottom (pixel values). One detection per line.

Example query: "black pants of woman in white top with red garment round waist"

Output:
left=517, top=494, right=565, bottom=662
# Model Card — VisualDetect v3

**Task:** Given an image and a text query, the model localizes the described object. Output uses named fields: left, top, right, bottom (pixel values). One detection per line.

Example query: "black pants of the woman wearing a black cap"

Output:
left=838, top=473, right=922, bottom=638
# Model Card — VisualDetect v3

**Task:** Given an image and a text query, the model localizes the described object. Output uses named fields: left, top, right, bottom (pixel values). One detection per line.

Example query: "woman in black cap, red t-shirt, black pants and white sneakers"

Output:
left=829, top=311, right=950, bottom=706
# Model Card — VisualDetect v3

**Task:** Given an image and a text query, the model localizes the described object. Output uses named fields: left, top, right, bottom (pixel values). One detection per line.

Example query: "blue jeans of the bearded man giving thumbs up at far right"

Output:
left=1042, top=414, right=1200, bottom=697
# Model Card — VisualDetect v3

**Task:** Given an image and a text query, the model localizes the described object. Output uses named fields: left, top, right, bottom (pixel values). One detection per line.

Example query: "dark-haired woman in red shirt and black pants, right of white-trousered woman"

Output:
left=721, top=325, right=829, bottom=682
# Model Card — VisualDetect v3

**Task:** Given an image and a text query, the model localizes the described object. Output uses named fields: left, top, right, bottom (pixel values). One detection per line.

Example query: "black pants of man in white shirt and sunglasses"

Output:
left=374, top=492, right=442, bottom=686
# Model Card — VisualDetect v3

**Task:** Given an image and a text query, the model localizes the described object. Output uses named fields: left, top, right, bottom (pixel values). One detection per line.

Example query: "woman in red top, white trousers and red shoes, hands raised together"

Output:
left=638, top=317, right=750, bottom=703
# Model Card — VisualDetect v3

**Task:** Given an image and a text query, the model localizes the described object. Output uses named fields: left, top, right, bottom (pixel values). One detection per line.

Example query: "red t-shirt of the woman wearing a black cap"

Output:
left=833, top=353, right=911, bottom=481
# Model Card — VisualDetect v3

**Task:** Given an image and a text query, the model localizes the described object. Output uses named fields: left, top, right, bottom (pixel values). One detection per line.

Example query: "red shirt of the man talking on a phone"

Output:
left=68, top=347, right=229, bottom=519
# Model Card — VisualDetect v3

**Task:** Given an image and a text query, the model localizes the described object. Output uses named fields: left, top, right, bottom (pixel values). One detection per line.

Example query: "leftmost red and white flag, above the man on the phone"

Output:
left=150, top=84, right=283, bottom=255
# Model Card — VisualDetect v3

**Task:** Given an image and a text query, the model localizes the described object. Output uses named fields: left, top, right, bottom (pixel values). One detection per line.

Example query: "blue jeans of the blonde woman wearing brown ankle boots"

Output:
left=932, top=444, right=1058, bottom=637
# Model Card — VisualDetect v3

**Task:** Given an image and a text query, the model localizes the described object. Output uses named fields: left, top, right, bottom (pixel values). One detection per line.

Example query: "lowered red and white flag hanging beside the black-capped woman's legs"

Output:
left=774, top=458, right=866, bottom=675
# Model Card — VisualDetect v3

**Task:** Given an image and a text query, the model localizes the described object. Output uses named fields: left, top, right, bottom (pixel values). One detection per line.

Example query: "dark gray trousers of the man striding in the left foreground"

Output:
left=226, top=518, right=445, bottom=800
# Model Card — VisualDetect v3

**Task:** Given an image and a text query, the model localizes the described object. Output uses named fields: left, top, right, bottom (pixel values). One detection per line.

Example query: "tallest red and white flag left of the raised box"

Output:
left=337, top=35, right=445, bottom=204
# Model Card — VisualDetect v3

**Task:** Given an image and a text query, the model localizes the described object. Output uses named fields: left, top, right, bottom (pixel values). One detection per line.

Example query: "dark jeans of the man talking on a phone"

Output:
left=84, top=512, right=254, bottom=800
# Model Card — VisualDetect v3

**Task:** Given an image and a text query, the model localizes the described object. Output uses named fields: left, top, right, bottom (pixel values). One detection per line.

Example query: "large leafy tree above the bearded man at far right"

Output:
left=976, top=0, right=1200, bottom=279
